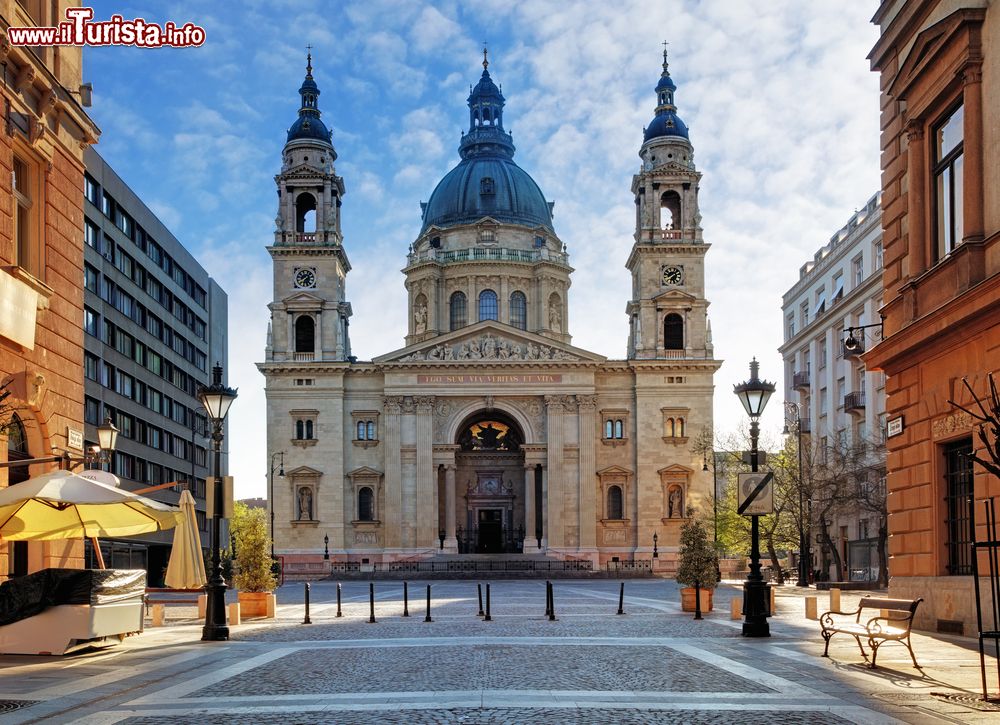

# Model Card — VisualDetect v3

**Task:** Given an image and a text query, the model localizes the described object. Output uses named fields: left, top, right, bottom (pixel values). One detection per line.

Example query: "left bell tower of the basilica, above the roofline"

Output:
left=266, top=53, right=351, bottom=362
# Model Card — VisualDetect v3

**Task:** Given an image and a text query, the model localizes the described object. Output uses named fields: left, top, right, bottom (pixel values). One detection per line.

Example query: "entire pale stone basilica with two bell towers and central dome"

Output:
left=258, top=54, right=721, bottom=572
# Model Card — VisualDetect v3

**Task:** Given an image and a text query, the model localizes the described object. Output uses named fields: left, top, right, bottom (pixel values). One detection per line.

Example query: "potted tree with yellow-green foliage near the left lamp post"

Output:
left=231, top=501, right=277, bottom=618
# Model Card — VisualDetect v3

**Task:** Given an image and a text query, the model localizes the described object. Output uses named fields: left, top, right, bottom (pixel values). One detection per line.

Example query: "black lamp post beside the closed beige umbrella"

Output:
left=198, top=363, right=236, bottom=642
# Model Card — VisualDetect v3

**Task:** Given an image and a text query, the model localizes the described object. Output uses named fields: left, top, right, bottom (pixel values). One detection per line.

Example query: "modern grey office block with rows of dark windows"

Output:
left=83, top=148, right=228, bottom=585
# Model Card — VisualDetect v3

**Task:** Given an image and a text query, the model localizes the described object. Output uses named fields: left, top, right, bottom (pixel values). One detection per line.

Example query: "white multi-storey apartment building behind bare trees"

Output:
left=779, top=193, right=885, bottom=580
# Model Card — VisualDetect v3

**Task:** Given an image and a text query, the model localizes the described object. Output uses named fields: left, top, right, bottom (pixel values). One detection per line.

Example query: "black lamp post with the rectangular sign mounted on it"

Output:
left=733, top=358, right=774, bottom=637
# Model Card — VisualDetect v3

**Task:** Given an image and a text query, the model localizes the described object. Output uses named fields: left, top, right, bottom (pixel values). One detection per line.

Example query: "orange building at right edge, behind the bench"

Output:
left=864, top=0, right=1000, bottom=634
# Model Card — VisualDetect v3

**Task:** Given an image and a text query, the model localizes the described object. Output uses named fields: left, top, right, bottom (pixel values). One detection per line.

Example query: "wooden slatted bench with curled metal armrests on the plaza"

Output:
left=819, top=597, right=924, bottom=670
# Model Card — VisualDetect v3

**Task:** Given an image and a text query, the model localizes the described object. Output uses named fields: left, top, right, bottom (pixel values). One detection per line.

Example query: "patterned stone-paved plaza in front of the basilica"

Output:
left=0, top=580, right=1000, bottom=725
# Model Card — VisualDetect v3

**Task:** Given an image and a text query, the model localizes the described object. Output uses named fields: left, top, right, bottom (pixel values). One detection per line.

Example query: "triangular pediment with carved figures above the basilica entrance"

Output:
left=372, top=320, right=607, bottom=365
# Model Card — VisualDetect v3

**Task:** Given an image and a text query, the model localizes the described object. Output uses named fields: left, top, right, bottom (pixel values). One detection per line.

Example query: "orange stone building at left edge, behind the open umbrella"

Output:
left=0, top=0, right=99, bottom=580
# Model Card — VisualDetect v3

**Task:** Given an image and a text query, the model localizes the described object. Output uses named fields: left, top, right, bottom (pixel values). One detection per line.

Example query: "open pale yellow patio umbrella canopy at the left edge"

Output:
left=0, top=471, right=182, bottom=551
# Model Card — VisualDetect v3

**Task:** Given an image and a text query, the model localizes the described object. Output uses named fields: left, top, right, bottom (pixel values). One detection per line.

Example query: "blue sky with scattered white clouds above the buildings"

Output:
left=84, top=0, right=880, bottom=498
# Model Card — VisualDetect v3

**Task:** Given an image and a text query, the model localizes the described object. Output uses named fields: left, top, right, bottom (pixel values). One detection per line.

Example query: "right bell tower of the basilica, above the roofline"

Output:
left=625, top=50, right=713, bottom=360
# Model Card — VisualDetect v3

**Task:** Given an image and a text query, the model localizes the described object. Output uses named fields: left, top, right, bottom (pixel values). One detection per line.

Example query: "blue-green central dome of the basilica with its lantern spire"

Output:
left=422, top=57, right=554, bottom=233
